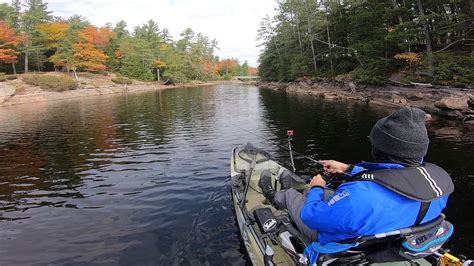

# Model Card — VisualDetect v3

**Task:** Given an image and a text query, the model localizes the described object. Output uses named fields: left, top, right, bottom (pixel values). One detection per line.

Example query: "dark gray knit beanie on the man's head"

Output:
left=370, top=107, right=430, bottom=159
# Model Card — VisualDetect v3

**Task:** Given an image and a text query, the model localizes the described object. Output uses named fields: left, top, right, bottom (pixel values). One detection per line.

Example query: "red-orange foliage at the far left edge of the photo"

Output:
left=0, top=21, right=23, bottom=64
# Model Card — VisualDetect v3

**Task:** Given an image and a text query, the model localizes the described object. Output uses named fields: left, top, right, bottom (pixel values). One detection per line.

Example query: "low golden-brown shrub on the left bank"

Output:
left=22, top=74, right=78, bottom=92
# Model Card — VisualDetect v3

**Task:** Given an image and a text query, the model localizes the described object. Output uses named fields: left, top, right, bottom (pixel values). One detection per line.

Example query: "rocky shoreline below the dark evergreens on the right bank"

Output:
left=256, top=79, right=474, bottom=125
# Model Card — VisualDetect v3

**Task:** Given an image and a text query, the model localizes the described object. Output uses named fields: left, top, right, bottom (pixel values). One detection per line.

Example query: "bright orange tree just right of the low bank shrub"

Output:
left=74, top=43, right=108, bottom=72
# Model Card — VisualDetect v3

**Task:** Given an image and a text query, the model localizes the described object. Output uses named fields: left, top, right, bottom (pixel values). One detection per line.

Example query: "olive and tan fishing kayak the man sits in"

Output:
left=230, top=144, right=450, bottom=265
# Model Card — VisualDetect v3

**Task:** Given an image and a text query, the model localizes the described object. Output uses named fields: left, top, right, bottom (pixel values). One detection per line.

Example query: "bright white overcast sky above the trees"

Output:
left=0, top=0, right=276, bottom=66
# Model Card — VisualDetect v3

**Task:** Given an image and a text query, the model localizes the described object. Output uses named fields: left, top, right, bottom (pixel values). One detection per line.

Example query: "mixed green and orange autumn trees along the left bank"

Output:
left=0, top=0, right=255, bottom=83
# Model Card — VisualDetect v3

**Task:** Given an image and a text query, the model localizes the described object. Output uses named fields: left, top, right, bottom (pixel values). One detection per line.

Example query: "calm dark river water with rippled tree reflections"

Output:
left=0, top=85, right=474, bottom=265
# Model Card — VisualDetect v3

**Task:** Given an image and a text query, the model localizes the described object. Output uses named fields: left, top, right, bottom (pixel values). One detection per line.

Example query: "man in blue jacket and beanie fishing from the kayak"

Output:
left=259, top=107, right=454, bottom=255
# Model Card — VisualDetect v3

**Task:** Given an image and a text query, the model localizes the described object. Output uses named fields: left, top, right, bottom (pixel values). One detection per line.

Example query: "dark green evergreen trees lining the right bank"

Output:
left=259, top=0, right=474, bottom=85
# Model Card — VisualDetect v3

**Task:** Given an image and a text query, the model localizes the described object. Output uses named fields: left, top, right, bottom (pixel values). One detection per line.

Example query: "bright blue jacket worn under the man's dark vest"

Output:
left=300, top=163, right=448, bottom=244
